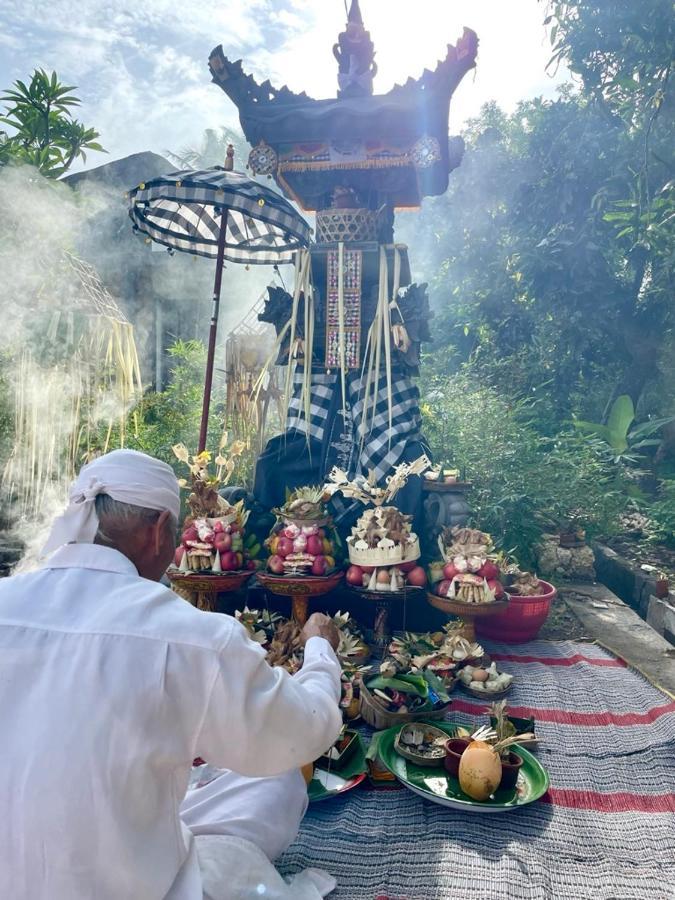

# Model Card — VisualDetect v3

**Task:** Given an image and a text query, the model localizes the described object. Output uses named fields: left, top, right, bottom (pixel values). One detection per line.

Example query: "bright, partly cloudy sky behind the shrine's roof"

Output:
left=0, top=0, right=569, bottom=171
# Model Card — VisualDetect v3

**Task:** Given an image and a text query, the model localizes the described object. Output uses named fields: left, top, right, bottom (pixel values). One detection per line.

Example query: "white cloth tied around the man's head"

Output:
left=42, top=450, right=180, bottom=556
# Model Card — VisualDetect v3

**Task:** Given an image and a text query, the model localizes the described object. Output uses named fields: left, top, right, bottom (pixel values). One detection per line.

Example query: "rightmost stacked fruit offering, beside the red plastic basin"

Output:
left=431, top=526, right=504, bottom=603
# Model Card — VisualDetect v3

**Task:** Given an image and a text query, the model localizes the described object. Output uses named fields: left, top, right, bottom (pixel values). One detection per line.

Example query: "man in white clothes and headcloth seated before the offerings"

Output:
left=0, top=450, right=342, bottom=900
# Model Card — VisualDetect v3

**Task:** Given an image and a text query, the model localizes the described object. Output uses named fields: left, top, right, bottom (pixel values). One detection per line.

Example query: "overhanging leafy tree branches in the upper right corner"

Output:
left=545, top=0, right=675, bottom=401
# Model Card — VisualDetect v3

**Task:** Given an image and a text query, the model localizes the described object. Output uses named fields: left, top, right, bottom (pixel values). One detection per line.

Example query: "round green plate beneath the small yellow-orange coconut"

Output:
left=378, top=722, right=549, bottom=813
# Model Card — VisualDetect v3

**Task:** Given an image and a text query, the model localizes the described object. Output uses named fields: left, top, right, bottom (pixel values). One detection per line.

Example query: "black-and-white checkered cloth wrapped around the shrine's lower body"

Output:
left=286, top=371, right=422, bottom=482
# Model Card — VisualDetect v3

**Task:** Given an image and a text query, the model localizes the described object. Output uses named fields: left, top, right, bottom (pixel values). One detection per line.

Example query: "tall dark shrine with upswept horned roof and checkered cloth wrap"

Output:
left=209, top=0, right=478, bottom=525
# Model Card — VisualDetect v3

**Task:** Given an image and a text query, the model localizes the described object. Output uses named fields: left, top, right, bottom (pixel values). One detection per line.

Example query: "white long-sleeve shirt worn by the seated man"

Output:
left=0, top=544, right=341, bottom=900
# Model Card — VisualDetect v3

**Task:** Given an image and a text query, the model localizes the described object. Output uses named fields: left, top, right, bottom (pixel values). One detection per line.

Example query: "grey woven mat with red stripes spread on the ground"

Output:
left=279, top=641, right=675, bottom=900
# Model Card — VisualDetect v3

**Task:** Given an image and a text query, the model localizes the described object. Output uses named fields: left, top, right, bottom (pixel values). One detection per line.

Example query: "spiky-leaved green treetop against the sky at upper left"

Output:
left=0, top=69, right=106, bottom=178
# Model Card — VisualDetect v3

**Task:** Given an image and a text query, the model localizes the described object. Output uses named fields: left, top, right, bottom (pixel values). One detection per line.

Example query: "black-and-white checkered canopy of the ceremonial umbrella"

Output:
left=129, top=166, right=310, bottom=265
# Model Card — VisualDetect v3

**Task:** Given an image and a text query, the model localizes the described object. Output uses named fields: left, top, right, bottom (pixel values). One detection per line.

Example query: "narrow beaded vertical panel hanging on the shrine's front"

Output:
left=326, top=247, right=362, bottom=369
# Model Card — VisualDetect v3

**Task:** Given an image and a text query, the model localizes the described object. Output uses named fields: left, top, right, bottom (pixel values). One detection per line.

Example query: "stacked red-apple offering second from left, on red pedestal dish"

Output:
left=265, top=487, right=336, bottom=576
